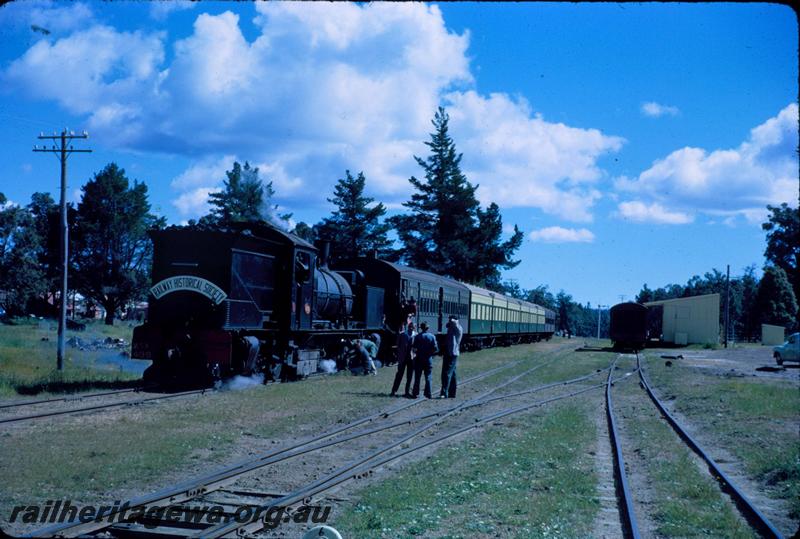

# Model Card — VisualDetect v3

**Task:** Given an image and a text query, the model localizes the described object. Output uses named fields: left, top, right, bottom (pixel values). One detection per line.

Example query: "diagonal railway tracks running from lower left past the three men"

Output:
left=26, top=348, right=608, bottom=537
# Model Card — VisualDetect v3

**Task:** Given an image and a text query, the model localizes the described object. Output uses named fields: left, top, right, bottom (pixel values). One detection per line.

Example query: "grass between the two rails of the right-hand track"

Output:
left=615, top=376, right=754, bottom=538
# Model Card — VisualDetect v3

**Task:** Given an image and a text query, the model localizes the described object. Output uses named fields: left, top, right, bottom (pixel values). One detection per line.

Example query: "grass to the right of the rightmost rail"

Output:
left=647, top=361, right=800, bottom=519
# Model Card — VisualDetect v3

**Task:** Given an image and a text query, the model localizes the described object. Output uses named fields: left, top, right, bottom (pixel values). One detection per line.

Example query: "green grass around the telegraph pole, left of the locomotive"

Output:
left=0, top=319, right=139, bottom=397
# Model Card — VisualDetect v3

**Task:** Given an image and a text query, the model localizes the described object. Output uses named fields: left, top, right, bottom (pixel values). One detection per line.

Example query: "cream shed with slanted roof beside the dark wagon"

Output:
left=644, top=294, right=720, bottom=344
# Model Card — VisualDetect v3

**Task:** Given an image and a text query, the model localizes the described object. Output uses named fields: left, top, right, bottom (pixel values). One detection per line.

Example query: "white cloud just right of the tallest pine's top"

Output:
left=447, top=91, right=625, bottom=222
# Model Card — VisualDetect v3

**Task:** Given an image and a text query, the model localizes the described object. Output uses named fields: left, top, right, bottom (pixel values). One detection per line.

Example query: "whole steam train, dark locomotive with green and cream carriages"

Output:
left=131, top=223, right=555, bottom=384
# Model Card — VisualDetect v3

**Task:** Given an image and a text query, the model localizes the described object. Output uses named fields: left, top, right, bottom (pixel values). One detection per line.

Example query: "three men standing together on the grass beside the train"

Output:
left=391, top=315, right=464, bottom=399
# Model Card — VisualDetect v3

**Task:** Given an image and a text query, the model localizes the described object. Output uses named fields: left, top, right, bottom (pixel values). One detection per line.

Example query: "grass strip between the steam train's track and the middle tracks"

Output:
left=0, top=344, right=588, bottom=528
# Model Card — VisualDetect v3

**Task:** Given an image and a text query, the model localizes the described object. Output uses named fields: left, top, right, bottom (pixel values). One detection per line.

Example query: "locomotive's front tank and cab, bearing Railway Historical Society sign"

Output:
left=132, top=225, right=316, bottom=384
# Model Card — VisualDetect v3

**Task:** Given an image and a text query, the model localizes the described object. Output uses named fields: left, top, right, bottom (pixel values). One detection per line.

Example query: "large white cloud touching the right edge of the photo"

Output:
left=615, top=103, right=798, bottom=222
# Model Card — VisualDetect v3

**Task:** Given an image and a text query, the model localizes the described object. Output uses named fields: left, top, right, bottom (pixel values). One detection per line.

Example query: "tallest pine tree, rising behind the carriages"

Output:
left=390, top=107, right=522, bottom=285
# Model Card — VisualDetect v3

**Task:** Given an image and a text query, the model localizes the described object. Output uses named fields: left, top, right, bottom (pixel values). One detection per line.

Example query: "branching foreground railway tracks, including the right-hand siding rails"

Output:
left=17, top=348, right=782, bottom=539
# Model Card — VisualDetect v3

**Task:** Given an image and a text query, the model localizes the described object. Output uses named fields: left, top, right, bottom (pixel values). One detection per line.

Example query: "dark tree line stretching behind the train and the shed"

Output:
left=0, top=107, right=800, bottom=337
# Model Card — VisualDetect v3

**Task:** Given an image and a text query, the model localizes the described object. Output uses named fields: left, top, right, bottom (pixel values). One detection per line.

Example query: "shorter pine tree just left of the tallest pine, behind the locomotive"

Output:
left=314, top=170, right=392, bottom=260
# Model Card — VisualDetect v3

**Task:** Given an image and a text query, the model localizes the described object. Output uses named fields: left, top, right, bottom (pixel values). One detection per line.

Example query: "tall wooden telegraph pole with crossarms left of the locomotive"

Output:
left=33, top=128, right=92, bottom=370
